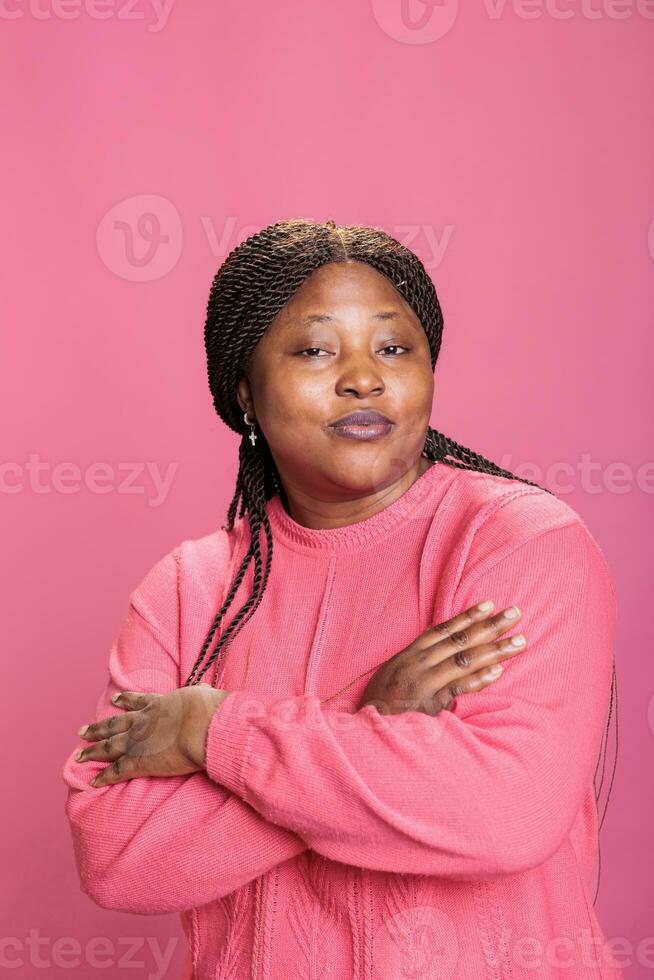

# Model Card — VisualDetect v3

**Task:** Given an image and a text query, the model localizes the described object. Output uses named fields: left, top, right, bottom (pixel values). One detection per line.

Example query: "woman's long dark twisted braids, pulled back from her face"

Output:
left=185, top=219, right=613, bottom=904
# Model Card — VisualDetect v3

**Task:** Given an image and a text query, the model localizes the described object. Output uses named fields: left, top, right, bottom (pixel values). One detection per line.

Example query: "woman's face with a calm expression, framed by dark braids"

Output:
left=238, top=260, right=434, bottom=502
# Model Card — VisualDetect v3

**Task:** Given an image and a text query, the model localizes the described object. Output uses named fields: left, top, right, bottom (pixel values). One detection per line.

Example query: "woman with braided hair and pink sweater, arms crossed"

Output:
left=64, top=220, right=622, bottom=980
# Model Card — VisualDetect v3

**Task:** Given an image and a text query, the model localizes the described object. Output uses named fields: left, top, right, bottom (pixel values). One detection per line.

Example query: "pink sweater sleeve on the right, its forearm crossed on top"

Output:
left=208, top=510, right=616, bottom=879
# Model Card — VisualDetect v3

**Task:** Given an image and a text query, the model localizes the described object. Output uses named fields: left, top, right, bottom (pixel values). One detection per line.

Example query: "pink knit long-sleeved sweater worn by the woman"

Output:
left=64, top=463, right=622, bottom=980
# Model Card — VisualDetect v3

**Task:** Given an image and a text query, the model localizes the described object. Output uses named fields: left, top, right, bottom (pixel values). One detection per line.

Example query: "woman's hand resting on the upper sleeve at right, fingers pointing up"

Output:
left=357, top=604, right=527, bottom=715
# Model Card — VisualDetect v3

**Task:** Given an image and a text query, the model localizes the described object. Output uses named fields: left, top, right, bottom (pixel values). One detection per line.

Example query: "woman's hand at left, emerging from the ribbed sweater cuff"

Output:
left=75, top=683, right=230, bottom=786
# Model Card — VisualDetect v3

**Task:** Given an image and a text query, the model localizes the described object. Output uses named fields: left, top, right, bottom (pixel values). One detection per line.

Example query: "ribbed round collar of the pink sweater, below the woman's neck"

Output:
left=266, top=462, right=453, bottom=553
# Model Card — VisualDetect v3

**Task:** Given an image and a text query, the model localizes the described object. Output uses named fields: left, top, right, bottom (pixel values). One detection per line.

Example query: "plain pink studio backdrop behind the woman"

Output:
left=0, top=0, right=654, bottom=980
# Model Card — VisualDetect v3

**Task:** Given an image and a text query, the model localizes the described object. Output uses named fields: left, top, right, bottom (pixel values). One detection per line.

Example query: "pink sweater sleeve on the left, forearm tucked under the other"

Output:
left=63, top=551, right=306, bottom=914
